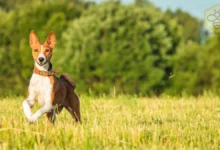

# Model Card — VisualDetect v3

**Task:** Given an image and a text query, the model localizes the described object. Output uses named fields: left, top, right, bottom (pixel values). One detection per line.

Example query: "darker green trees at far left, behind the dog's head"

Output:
left=0, top=0, right=84, bottom=94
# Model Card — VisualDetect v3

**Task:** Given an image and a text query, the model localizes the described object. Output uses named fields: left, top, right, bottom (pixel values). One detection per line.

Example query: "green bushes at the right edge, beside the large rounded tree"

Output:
left=173, top=35, right=220, bottom=94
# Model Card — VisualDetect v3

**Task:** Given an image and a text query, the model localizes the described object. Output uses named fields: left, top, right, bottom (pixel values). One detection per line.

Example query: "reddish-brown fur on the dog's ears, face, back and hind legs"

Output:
left=30, top=31, right=80, bottom=123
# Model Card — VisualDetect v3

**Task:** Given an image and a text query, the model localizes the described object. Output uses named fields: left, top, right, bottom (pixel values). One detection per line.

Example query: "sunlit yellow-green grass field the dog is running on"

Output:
left=0, top=96, right=220, bottom=150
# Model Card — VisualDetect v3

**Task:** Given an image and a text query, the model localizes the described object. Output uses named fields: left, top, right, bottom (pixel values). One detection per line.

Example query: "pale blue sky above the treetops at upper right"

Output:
left=95, top=0, right=220, bottom=19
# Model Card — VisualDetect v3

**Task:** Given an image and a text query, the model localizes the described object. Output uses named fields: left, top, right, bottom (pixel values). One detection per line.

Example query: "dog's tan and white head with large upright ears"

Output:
left=29, top=30, right=56, bottom=66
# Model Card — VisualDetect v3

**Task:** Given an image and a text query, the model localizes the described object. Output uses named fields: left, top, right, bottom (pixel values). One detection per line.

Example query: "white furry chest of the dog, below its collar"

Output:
left=29, top=74, right=53, bottom=106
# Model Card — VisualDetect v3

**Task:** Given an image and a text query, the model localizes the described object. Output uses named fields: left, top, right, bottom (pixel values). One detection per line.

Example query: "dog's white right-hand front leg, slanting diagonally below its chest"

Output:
left=28, top=103, right=53, bottom=123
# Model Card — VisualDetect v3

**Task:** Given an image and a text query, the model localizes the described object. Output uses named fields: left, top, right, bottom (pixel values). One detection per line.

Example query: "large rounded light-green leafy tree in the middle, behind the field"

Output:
left=54, top=3, right=181, bottom=93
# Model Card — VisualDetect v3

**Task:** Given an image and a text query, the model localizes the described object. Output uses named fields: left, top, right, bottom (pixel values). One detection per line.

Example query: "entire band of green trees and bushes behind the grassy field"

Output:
left=0, top=0, right=220, bottom=95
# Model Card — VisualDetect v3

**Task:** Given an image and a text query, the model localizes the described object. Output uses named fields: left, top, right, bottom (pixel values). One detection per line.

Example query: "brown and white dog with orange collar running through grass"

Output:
left=22, top=31, right=80, bottom=123
